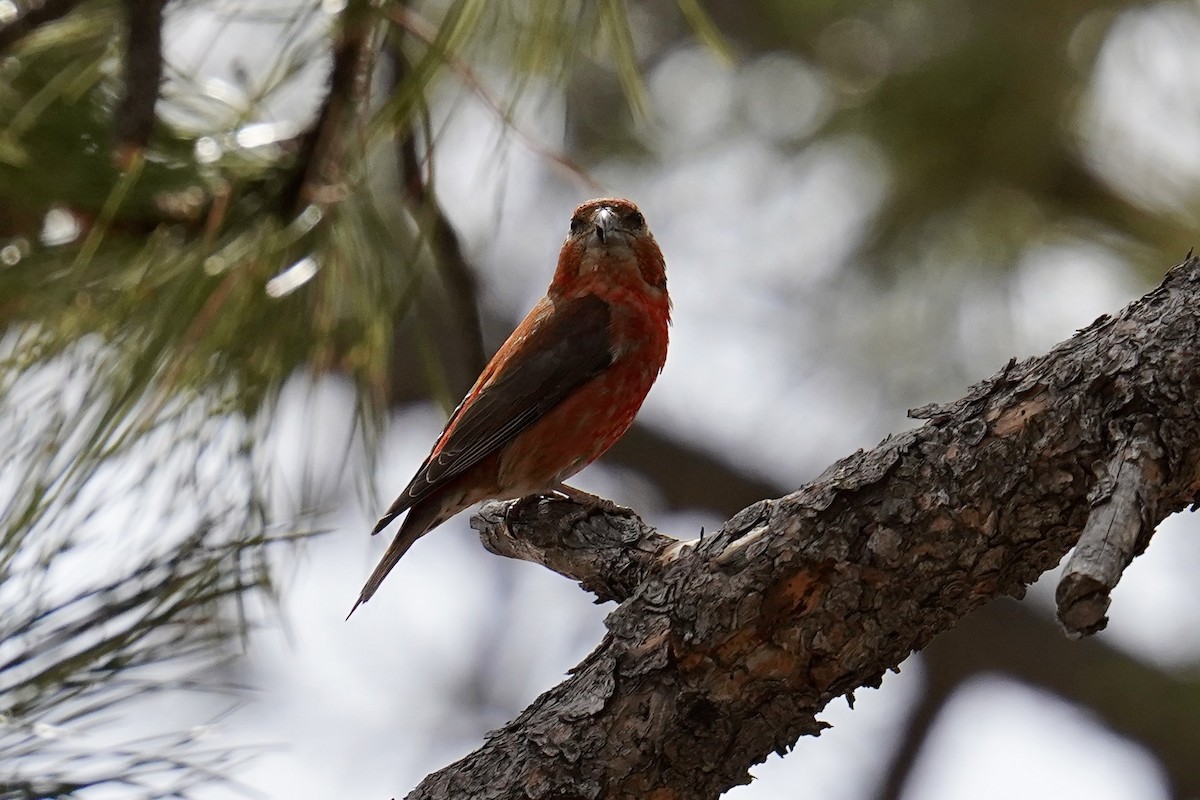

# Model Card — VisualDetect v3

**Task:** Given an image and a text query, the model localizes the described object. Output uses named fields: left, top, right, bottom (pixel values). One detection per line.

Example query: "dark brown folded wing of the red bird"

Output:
left=372, top=295, right=612, bottom=533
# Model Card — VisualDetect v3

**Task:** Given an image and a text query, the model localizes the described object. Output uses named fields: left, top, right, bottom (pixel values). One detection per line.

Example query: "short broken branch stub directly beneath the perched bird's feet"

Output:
left=470, top=495, right=690, bottom=602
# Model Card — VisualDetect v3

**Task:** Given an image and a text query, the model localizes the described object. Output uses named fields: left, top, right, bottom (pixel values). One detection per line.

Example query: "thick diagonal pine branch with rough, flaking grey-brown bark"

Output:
left=409, top=258, right=1200, bottom=800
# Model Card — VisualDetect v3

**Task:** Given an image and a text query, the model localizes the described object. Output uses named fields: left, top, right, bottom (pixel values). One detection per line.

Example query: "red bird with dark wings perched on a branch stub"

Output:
left=347, top=198, right=671, bottom=618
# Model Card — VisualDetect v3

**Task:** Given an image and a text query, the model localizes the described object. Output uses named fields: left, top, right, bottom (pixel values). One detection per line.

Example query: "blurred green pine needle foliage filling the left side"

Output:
left=0, top=0, right=715, bottom=800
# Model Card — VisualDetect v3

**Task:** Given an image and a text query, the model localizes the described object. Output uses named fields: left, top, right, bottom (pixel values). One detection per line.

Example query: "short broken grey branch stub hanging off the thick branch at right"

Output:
left=1055, top=420, right=1163, bottom=637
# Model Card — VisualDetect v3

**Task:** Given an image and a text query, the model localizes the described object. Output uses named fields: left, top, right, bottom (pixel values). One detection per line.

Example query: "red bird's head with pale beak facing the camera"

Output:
left=551, top=198, right=667, bottom=302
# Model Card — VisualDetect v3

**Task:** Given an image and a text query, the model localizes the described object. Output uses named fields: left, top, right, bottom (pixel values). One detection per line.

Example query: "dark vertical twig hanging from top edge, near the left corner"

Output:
left=113, top=0, right=167, bottom=170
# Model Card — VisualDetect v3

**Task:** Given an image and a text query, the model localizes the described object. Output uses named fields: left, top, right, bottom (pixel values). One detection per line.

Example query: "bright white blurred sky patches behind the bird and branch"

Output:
left=42, top=5, right=1200, bottom=800
